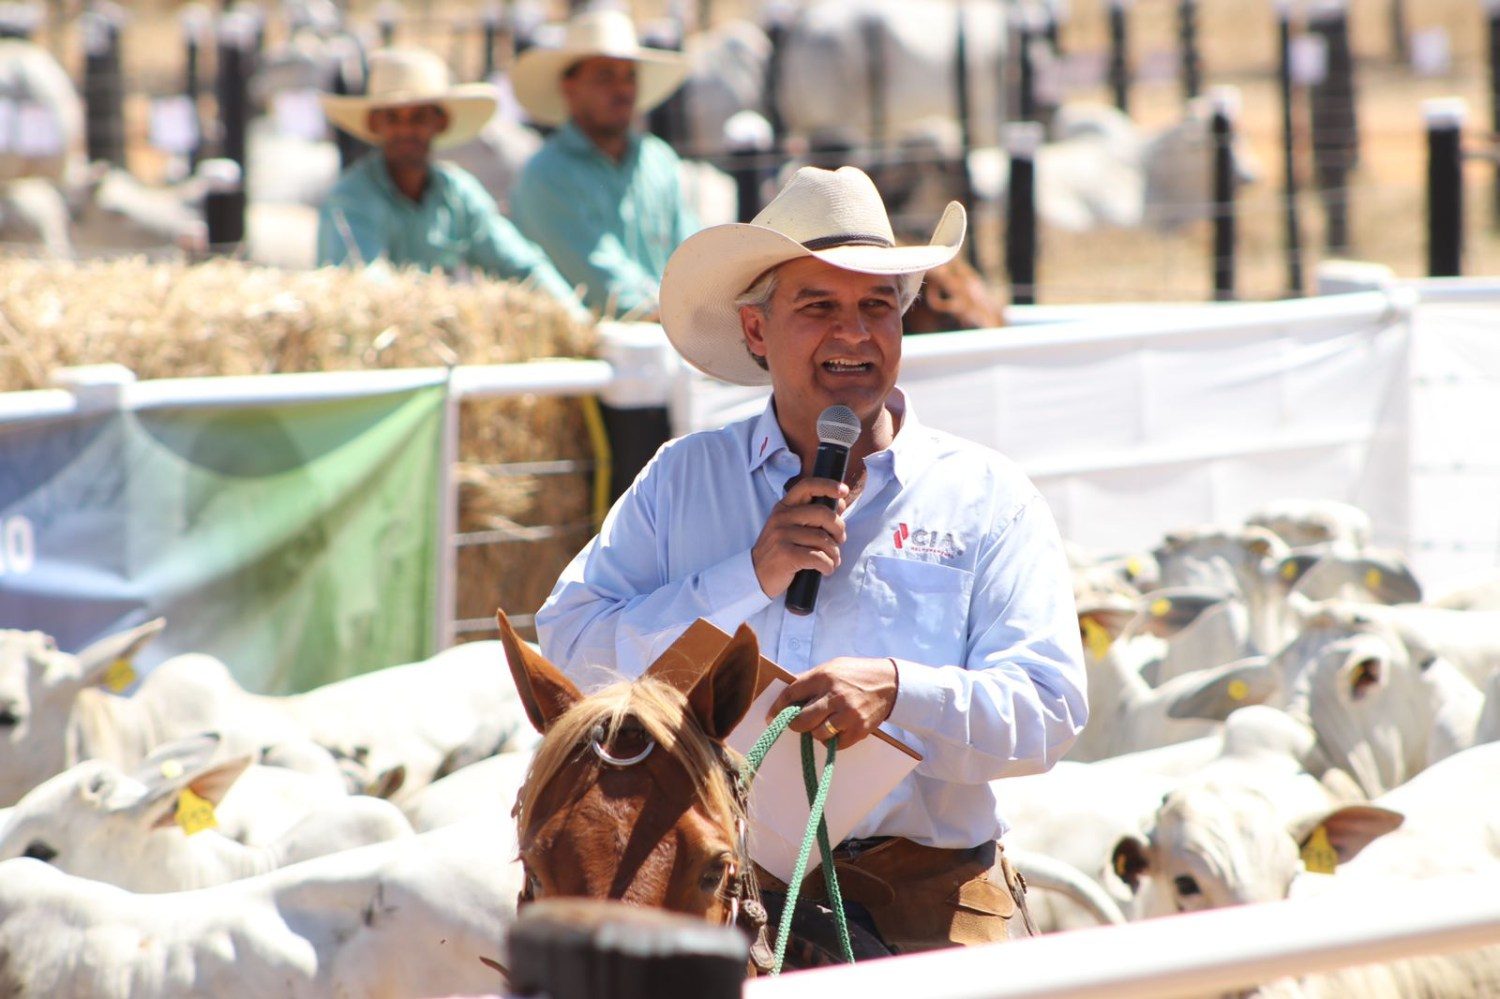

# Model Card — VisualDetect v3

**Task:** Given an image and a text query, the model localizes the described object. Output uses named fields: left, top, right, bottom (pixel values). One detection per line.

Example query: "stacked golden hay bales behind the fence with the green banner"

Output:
left=0, top=258, right=596, bottom=638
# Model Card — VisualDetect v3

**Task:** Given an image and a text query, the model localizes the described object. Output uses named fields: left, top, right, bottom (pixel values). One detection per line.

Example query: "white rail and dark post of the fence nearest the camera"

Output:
left=512, top=875, right=1500, bottom=999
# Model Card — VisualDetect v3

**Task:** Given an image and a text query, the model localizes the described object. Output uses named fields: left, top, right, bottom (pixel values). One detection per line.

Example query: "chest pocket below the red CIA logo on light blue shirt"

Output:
left=855, top=555, right=974, bottom=666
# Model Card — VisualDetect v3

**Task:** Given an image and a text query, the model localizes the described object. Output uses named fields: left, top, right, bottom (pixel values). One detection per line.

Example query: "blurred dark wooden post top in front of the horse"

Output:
left=507, top=899, right=750, bottom=999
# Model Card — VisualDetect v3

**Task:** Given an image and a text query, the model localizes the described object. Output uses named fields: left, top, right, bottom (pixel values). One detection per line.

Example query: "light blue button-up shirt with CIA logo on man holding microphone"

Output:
left=537, top=393, right=1088, bottom=848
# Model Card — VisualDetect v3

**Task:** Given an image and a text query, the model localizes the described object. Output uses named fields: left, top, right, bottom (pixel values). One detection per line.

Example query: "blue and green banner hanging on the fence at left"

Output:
left=0, top=384, right=446, bottom=693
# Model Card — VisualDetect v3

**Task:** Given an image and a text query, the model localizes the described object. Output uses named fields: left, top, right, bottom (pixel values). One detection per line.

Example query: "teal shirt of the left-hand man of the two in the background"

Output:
left=318, top=150, right=582, bottom=312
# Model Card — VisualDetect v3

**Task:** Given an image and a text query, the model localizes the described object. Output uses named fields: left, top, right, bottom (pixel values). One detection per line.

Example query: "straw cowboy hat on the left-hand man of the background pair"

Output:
left=320, top=48, right=500, bottom=149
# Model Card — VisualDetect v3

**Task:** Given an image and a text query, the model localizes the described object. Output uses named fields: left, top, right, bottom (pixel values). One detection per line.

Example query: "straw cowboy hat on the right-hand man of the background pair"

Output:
left=510, top=11, right=687, bottom=125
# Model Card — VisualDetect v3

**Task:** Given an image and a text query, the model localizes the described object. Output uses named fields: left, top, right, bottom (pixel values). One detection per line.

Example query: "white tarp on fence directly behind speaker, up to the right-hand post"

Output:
left=674, top=293, right=1415, bottom=567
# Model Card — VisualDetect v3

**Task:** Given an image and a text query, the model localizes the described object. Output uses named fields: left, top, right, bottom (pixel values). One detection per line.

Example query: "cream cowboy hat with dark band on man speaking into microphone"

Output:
left=662, top=167, right=966, bottom=386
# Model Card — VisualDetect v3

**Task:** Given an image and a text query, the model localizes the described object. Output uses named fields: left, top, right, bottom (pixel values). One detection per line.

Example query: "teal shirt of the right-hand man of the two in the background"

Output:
left=510, top=122, right=698, bottom=315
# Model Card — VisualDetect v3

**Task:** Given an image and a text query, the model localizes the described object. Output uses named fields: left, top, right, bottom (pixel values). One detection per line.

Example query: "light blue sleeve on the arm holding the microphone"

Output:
left=537, top=447, right=770, bottom=684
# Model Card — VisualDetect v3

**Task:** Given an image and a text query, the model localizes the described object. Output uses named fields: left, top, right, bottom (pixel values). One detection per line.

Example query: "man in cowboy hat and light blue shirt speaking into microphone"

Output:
left=537, top=167, right=1088, bottom=951
